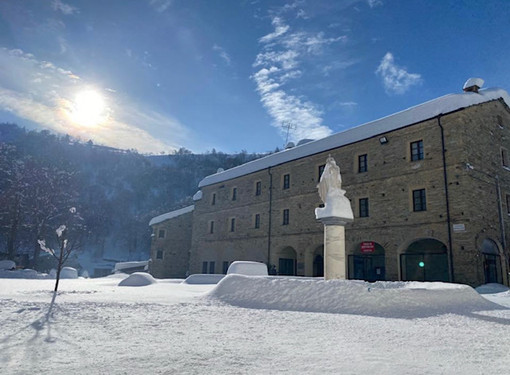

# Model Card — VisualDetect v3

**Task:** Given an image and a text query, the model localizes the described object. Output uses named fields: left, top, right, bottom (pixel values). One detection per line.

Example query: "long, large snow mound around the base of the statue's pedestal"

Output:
left=208, top=275, right=503, bottom=319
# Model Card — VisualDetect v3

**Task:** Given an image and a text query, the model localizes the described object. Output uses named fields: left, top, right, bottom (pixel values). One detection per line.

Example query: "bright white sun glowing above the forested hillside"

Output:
left=70, top=90, right=107, bottom=127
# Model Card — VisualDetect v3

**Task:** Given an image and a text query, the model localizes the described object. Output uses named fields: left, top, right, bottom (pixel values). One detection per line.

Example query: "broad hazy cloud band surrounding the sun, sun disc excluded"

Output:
left=0, top=48, right=189, bottom=152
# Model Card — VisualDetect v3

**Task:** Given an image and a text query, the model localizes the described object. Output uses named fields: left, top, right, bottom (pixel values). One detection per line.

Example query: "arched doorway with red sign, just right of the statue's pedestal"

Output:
left=348, top=241, right=385, bottom=281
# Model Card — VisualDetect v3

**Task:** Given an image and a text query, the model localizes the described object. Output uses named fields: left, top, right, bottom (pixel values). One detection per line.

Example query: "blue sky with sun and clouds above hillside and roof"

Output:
left=0, top=0, right=510, bottom=153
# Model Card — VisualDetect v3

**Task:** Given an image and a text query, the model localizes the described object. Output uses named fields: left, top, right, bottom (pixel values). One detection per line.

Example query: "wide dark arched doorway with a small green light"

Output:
left=400, top=238, right=450, bottom=281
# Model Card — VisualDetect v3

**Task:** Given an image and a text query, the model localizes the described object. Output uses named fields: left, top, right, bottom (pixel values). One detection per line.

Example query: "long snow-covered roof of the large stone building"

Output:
left=198, top=88, right=510, bottom=187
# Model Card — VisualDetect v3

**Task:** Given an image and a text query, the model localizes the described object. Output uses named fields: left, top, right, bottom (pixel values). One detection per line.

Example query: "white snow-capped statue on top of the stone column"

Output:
left=315, top=155, right=354, bottom=221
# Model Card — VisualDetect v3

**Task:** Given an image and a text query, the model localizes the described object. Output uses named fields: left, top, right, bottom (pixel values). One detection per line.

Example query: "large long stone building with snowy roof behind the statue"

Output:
left=153, top=85, right=510, bottom=286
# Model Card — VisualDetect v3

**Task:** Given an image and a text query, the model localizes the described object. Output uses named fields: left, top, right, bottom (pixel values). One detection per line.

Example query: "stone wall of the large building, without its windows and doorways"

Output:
left=190, top=100, right=510, bottom=285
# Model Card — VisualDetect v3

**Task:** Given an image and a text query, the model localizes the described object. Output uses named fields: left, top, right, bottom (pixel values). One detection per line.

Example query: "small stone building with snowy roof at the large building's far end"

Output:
left=149, top=206, right=194, bottom=278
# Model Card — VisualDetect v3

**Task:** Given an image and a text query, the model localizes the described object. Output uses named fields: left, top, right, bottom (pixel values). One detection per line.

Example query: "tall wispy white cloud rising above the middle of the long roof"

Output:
left=251, top=15, right=346, bottom=141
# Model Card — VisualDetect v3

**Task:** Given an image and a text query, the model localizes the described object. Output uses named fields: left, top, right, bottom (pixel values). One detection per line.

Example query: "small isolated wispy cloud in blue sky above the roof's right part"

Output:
left=375, top=52, right=422, bottom=94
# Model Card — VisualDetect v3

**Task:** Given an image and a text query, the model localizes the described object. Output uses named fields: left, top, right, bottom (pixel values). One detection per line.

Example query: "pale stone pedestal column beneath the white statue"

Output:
left=320, top=217, right=352, bottom=280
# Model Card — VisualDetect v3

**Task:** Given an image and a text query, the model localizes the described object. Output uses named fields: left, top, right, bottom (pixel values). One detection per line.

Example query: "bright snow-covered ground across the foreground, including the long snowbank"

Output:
left=0, top=275, right=510, bottom=375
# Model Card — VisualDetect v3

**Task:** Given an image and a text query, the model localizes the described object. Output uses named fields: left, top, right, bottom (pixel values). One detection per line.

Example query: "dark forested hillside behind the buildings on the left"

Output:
left=0, top=124, right=259, bottom=270
